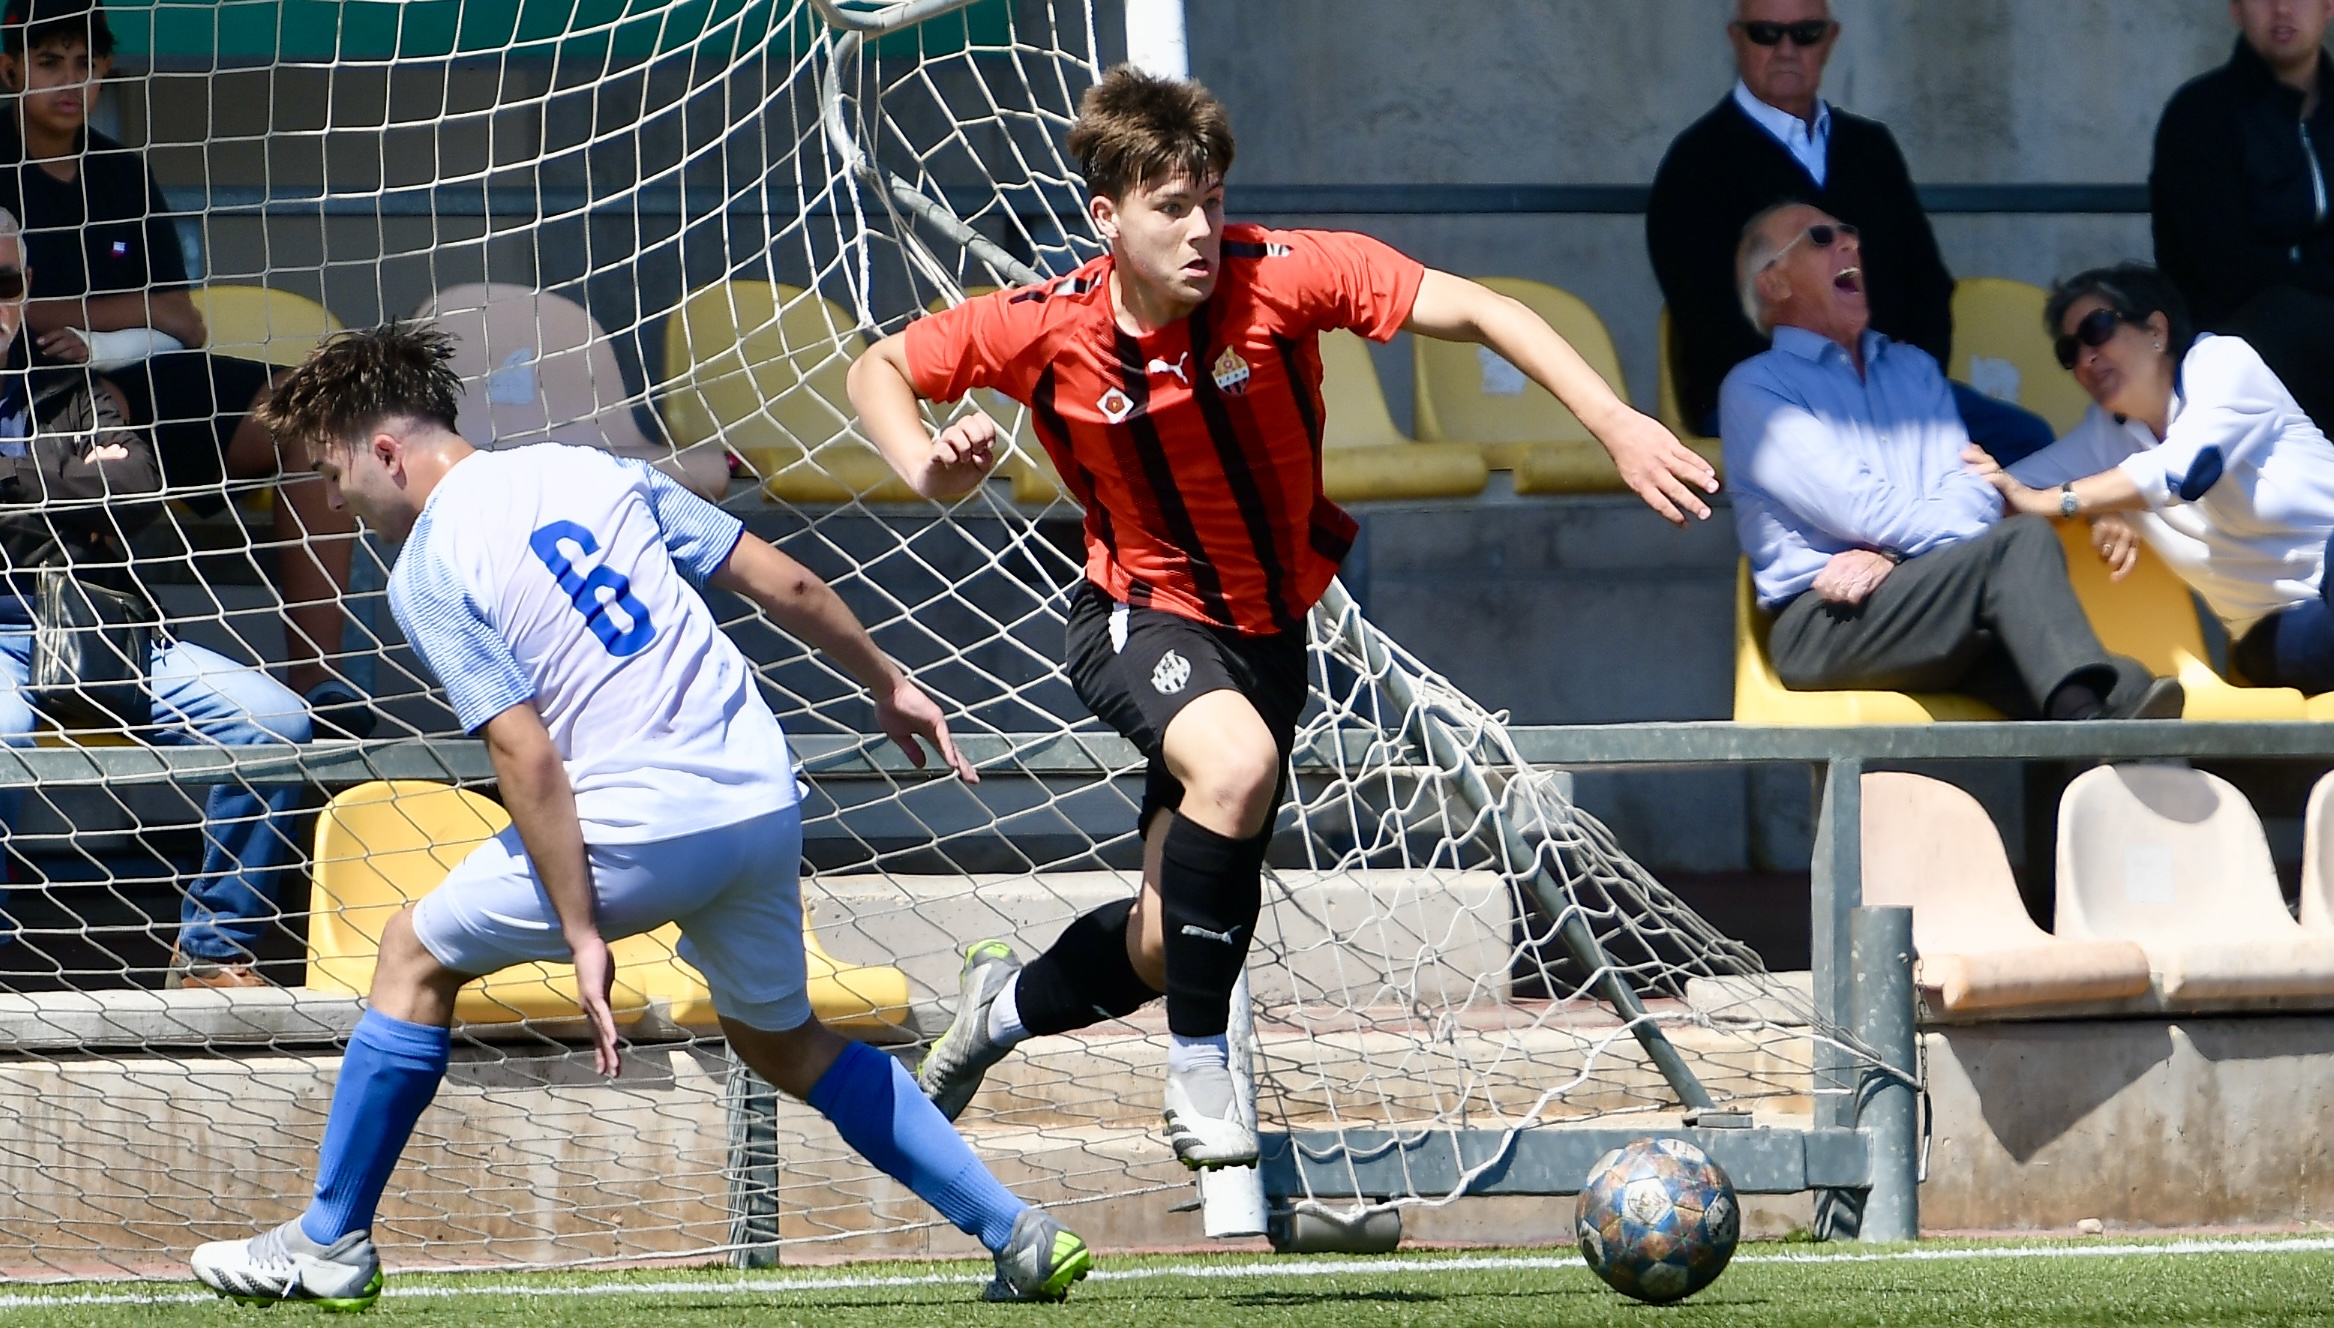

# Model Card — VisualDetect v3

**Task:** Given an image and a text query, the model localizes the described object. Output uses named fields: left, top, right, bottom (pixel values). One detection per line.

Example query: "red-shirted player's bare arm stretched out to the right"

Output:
left=1403, top=268, right=1718, bottom=525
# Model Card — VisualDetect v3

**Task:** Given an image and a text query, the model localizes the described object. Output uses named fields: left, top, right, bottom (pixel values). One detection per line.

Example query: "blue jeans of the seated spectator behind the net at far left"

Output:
left=0, top=623, right=308, bottom=964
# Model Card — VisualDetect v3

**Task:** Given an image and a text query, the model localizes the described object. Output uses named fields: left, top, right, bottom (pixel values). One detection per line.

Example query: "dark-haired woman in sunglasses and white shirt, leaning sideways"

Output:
left=1970, top=264, right=2334, bottom=693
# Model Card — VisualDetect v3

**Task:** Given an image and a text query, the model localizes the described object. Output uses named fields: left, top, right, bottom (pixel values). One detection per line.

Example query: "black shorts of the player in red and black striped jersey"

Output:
left=1062, top=581, right=1312, bottom=831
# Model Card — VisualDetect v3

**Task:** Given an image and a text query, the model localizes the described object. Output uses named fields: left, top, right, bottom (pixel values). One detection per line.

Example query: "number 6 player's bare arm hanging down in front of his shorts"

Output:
left=481, top=700, right=621, bottom=1076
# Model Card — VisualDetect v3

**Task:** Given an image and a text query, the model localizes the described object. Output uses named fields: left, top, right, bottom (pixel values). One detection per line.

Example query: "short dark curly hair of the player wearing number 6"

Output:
left=259, top=322, right=462, bottom=450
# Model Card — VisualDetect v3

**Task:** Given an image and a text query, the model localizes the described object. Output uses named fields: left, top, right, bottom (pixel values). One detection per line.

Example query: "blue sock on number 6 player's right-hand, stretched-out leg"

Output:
left=810, top=1043, right=1029, bottom=1253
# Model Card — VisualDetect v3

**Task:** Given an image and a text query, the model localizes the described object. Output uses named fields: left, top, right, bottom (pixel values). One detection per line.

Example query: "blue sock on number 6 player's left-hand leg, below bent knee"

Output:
left=299, top=1011, right=453, bottom=1244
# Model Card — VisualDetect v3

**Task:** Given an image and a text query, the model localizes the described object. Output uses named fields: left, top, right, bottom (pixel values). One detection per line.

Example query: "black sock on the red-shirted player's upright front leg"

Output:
left=1160, top=815, right=1272, bottom=1039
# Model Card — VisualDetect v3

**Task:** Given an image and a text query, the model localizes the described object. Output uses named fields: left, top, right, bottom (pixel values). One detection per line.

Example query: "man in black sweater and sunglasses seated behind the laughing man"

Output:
left=1645, top=0, right=2054, bottom=457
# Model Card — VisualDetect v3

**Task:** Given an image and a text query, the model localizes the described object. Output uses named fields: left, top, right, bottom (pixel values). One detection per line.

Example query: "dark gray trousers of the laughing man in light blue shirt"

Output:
left=1769, top=516, right=2150, bottom=719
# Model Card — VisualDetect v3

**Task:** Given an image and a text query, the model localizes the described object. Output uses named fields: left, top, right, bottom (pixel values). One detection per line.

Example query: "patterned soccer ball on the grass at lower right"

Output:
left=1573, top=1139, right=1741, bottom=1305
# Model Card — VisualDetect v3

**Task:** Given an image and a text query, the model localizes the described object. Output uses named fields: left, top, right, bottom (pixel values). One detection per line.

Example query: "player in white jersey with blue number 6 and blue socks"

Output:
left=194, top=324, right=1092, bottom=1309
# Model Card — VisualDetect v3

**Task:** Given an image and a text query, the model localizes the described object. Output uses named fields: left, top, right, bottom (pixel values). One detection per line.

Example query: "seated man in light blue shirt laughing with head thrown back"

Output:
left=1720, top=203, right=2182, bottom=719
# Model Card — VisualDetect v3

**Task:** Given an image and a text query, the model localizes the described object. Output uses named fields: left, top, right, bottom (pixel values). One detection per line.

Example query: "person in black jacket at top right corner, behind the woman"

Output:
left=2147, top=0, right=2334, bottom=429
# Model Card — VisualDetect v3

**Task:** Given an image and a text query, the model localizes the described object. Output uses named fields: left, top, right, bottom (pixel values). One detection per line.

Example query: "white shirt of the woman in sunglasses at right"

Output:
left=2010, top=336, right=2334, bottom=637
